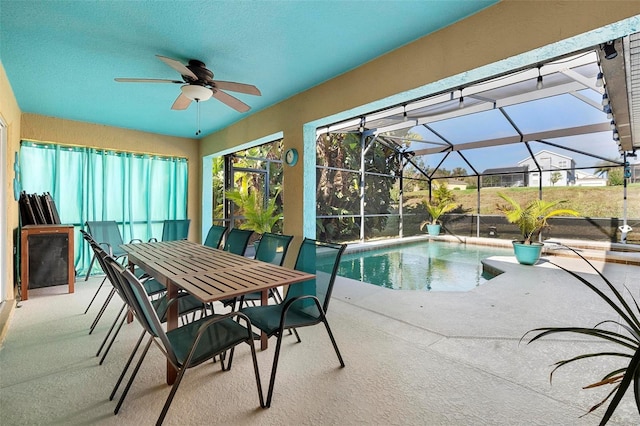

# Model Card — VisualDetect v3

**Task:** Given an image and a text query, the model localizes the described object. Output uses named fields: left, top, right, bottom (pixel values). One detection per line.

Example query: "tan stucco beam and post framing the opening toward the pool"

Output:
left=200, top=0, right=640, bottom=243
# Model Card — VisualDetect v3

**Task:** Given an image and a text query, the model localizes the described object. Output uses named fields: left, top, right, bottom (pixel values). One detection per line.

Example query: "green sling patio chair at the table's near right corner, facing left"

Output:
left=240, top=238, right=347, bottom=407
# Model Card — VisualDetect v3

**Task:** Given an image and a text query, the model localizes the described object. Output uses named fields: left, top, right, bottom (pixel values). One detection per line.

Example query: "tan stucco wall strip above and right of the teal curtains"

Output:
left=21, top=114, right=202, bottom=241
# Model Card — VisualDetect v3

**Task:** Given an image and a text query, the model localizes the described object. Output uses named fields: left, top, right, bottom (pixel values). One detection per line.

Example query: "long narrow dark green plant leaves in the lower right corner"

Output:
left=521, top=245, right=640, bottom=425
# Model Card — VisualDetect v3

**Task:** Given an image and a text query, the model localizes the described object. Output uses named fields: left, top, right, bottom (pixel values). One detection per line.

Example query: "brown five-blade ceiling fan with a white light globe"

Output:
left=115, top=55, right=261, bottom=112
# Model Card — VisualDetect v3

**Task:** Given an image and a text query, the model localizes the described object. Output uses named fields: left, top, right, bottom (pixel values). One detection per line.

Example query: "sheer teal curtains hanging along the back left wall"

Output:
left=20, top=141, right=188, bottom=275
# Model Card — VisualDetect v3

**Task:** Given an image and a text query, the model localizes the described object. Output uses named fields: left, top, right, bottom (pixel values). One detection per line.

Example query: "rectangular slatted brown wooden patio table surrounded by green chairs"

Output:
left=121, top=240, right=315, bottom=384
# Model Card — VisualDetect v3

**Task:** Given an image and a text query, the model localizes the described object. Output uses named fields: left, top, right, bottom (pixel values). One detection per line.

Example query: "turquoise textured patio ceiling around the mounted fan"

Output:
left=0, top=0, right=497, bottom=137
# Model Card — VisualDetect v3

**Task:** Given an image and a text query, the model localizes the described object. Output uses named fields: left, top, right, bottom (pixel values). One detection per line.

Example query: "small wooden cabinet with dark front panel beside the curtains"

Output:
left=20, top=225, right=75, bottom=300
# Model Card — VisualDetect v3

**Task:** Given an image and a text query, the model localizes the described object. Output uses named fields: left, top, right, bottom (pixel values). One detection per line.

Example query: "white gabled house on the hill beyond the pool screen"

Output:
left=518, top=150, right=576, bottom=187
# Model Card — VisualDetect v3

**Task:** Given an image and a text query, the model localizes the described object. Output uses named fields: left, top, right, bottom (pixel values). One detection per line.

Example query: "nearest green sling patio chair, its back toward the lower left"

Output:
left=106, top=258, right=264, bottom=425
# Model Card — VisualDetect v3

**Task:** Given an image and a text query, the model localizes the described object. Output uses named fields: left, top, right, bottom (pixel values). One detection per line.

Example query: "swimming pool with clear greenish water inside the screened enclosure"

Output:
left=338, top=241, right=513, bottom=291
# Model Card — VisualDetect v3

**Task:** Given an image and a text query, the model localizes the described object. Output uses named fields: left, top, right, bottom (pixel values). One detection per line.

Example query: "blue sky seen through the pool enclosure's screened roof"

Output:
left=402, top=90, right=637, bottom=176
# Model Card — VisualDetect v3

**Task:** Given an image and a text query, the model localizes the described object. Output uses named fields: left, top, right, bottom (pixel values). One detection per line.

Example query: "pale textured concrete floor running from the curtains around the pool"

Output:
left=0, top=257, right=640, bottom=425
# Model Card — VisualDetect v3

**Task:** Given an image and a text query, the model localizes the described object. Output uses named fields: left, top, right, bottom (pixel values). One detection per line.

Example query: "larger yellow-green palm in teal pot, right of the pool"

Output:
left=497, top=193, right=580, bottom=265
